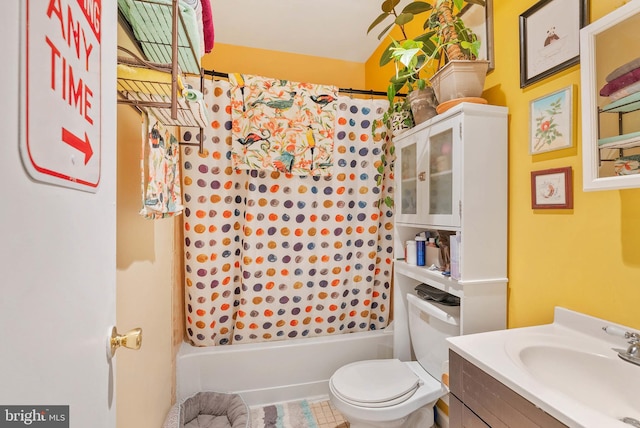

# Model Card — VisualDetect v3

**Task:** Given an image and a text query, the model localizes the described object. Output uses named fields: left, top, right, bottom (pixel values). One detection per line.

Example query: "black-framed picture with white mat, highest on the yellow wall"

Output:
left=520, top=0, right=589, bottom=88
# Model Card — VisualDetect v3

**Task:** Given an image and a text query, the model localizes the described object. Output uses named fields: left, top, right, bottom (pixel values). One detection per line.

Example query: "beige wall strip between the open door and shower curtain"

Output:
left=116, top=25, right=178, bottom=428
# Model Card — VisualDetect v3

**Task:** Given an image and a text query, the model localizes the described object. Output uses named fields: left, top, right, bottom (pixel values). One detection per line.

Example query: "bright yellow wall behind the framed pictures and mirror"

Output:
left=365, top=0, right=640, bottom=328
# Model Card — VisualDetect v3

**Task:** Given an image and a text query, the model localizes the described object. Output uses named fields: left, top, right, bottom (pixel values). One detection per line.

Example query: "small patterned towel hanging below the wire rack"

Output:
left=140, top=115, right=184, bottom=219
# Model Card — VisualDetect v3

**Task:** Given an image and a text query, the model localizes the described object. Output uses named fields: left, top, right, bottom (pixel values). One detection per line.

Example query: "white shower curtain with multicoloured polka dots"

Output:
left=181, top=80, right=393, bottom=346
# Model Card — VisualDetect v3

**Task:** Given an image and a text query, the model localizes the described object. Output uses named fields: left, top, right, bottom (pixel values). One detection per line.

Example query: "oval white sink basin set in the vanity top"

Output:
left=506, top=335, right=640, bottom=420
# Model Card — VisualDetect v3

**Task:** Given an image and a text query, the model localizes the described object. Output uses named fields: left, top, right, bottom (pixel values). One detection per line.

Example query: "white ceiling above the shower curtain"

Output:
left=211, top=0, right=409, bottom=63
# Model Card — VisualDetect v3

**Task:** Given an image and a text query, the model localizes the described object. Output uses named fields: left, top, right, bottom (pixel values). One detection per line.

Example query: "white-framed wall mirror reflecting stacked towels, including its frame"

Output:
left=580, top=0, right=640, bottom=191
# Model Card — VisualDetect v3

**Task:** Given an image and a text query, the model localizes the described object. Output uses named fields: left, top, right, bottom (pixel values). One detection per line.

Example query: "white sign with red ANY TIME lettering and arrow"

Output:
left=20, top=0, right=102, bottom=192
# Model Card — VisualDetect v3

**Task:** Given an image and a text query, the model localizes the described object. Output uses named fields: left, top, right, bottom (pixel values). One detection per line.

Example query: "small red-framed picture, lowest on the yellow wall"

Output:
left=531, top=166, right=573, bottom=209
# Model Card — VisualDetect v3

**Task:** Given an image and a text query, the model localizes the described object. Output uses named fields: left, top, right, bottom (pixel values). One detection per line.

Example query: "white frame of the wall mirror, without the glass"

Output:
left=580, top=0, right=640, bottom=191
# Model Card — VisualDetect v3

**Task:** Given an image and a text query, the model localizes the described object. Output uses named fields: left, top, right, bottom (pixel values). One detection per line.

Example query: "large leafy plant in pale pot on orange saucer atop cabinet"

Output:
left=368, top=0, right=488, bottom=113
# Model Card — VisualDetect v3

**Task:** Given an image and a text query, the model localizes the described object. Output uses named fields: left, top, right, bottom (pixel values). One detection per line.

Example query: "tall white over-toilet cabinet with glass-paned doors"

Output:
left=394, top=103, right=508, bottom=359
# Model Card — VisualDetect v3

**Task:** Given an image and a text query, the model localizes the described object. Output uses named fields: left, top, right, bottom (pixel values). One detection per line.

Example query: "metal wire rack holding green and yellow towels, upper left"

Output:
left=117, top=0, right=208, bottom=128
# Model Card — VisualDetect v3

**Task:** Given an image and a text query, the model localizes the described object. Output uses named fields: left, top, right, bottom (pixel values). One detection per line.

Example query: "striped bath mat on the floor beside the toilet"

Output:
left=251, top=400, right=318, bottom=428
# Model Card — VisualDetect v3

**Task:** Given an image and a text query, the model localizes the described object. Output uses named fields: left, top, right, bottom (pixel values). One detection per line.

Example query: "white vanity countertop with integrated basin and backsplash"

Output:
left=447, top=307, right=640, bottom=428
